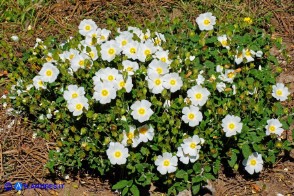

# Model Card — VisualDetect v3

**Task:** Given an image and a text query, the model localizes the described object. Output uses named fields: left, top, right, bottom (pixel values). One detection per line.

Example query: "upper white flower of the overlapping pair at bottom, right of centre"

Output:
left=181, top=135, right=201, bottom=156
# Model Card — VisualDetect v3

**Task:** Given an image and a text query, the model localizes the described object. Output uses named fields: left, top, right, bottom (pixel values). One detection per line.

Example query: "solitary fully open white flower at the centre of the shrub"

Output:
left=131, top=100, right=154, bottom=123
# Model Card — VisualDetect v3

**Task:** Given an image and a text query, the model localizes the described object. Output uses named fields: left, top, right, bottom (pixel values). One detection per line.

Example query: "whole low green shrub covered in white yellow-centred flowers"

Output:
left=2, top=13, right=293, bottom=195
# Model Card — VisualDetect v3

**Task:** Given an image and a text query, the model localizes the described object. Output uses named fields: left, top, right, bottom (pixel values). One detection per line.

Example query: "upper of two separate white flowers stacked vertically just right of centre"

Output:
left=187, top=85, right=210, bottom=106
